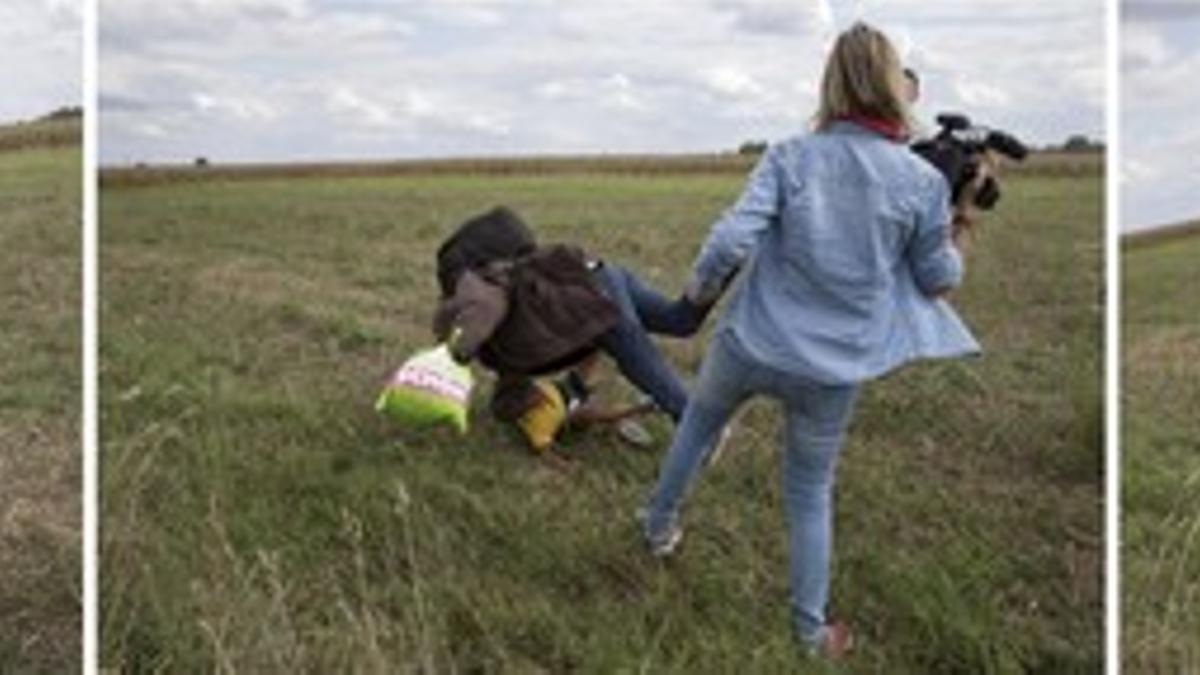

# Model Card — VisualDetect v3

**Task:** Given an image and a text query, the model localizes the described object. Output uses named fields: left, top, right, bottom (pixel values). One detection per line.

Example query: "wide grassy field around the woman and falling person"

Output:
left=101, top=156, right=1103, bottom=673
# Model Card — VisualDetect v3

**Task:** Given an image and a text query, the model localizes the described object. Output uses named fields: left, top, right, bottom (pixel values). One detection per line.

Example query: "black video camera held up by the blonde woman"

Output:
left=912, top=113, right=1028, bottom=210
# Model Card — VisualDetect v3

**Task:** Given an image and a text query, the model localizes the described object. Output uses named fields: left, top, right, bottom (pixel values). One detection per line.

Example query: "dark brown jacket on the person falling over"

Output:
left=433, top=245, right=618, bottom=375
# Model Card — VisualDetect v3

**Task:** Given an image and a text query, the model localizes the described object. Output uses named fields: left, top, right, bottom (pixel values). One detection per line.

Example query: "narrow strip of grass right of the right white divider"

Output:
left=1121, top=227, right=1200, bottom=673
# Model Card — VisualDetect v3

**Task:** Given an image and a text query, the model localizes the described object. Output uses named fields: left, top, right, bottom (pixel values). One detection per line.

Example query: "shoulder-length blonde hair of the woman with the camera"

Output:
left=814, top=22, right=913, bottom=132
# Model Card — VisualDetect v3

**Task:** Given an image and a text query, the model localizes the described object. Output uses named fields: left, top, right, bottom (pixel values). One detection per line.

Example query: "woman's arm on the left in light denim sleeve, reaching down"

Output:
left=686, top=145, right=782, bottom=305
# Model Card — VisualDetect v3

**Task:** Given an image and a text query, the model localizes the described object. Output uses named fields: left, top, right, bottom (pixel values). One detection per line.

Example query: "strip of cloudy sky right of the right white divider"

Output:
left=1121, top=0, right=1200, bottom=229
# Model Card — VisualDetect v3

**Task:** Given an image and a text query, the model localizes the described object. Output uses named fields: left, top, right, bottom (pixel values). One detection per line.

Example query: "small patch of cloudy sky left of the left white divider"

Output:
left=0, top=0, right=83, bottom=124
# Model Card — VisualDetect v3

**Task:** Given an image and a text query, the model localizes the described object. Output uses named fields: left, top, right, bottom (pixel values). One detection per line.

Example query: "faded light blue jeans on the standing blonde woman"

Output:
left=644, top=333, right=858, bottom=643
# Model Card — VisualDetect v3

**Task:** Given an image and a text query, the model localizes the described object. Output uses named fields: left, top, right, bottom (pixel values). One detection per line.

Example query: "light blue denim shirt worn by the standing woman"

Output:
left=694, top=121, right=979, bottom=384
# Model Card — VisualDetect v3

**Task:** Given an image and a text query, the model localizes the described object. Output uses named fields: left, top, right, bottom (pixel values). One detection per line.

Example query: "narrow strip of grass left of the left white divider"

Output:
left=0, top=127, right=82, bottom=673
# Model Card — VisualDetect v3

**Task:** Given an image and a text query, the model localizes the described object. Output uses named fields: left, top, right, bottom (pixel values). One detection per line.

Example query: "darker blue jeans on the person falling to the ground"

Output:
left=594, top=263, right=708, bottom=423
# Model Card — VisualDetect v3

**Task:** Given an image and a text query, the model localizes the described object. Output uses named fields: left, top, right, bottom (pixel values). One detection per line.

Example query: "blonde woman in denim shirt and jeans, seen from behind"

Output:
left=641, top=24, right=979, bottom=657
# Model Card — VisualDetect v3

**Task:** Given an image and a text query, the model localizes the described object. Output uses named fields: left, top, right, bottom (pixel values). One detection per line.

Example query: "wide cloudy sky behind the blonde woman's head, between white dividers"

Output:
left=98, top=0, right=1105, bottom=163
